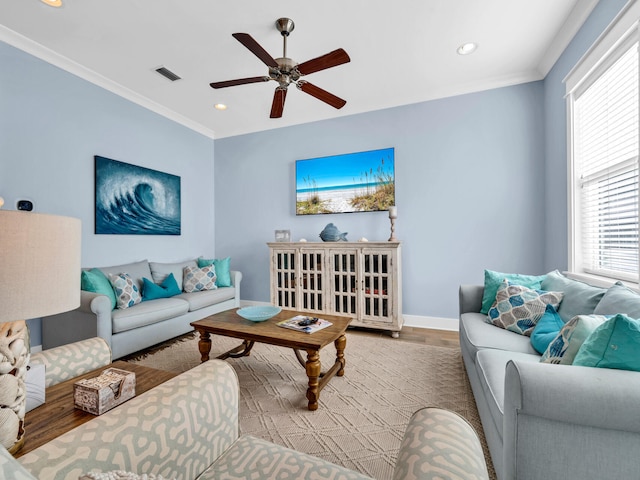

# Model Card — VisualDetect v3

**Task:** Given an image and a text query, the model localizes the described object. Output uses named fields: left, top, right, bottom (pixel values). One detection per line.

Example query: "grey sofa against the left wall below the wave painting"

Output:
left=42, top=259, right=242, bottom=359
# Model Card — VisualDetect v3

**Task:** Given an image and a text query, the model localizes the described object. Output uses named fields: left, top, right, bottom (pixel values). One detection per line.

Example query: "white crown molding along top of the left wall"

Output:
left=0, top=25, right=215, bottom=139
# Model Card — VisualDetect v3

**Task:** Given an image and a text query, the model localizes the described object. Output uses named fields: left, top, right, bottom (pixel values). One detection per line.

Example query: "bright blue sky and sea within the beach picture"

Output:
left=296, top=148, right=394, bottom=193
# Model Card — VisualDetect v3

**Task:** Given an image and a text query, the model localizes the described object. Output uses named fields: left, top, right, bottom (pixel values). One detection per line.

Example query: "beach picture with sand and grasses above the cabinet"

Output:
left=296, top=148, right=395, bottom=215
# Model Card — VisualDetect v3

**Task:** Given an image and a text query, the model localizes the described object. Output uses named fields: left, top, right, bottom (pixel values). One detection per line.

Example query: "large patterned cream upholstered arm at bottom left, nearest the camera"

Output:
left=18, top=360, right=240, bottom=480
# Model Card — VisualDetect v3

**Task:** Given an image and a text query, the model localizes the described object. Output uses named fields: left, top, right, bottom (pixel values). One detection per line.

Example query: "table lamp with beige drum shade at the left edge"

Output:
left=0, top=210, right=81, bottom=453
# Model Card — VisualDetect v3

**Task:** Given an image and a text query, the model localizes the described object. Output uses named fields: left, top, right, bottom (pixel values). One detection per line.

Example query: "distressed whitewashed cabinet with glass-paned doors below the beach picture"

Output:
left=267, top=242, right=403, bottom=337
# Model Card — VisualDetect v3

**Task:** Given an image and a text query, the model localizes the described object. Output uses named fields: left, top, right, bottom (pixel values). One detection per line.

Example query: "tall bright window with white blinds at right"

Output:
left=567, top=8, right=640, bottom=283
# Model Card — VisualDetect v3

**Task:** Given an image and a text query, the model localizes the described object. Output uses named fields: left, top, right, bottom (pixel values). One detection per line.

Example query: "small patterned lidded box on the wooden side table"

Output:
left=73, top=368, right=136, bottom=415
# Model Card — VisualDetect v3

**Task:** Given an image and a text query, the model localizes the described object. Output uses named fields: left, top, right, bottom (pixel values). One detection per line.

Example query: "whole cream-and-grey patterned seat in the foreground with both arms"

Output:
left=0, top=342, right=488, bottom=480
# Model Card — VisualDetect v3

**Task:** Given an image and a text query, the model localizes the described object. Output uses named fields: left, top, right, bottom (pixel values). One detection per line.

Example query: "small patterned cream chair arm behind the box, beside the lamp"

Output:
left=31, top=337, right=111, bottom=387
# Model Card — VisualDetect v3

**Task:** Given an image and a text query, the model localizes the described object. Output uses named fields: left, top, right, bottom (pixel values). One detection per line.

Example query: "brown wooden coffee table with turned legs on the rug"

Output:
left=191, top=309, right=351, bottom=410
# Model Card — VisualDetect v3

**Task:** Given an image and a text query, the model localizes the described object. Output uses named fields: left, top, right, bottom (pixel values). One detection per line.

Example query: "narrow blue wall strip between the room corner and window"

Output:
left=544, top=0, right=627, bottom=270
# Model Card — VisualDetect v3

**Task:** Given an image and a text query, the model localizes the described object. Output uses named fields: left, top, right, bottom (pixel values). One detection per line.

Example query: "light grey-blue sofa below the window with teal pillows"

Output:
left=459, top=271, right=640, bottom=480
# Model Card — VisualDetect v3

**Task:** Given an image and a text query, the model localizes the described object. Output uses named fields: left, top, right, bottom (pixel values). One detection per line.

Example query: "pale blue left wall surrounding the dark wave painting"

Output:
left=0, top=42, right=215, bottom=345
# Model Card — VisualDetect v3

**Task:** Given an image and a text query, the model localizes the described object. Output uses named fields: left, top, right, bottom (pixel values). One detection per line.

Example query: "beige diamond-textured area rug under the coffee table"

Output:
left=126, top=330, right=495, bottom=480
